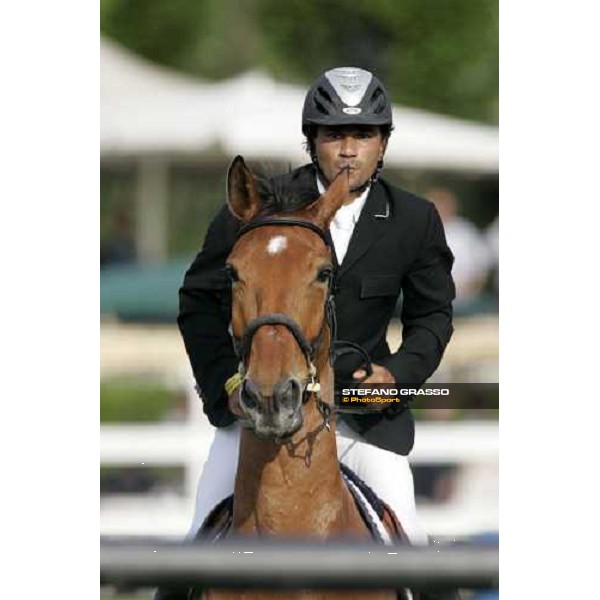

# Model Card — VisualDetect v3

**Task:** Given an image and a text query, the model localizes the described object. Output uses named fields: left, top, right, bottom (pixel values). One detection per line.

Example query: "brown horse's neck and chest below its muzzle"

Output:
left=233, top=366, right=348, bottom=538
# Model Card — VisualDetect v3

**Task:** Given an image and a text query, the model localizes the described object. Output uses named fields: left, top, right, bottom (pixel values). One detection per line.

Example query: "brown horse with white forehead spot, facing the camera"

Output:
left=205, top=157, right=406, bottom=600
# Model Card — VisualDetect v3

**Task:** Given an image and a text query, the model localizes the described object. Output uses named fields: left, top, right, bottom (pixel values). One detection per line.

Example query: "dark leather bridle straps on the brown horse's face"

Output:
left=233, top=217, right=337, bottom=430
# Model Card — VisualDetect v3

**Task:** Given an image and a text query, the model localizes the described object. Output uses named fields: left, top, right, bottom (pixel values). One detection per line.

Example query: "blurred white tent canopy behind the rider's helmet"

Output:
left=100, top=39, right=498, bottom=173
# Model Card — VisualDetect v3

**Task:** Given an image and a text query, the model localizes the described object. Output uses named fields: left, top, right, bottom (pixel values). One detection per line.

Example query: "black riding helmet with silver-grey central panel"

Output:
left=302, top=67, right=392, bottom=137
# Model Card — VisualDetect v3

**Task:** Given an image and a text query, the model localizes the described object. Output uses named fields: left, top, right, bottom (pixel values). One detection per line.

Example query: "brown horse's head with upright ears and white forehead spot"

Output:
left=227, top=157, right=349, bottom=439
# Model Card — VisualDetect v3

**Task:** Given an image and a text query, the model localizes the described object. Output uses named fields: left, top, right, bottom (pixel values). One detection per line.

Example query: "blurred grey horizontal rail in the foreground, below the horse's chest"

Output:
left=100, top=541, right=498, bottom=589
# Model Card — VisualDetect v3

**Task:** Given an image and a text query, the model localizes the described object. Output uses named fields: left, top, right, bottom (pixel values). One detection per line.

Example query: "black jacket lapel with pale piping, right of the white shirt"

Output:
left=338, top=183, right=392, bottom=277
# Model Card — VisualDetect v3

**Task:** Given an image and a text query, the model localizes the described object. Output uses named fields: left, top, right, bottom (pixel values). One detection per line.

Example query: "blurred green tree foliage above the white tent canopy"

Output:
left=101, top=0, right=498, bottom=122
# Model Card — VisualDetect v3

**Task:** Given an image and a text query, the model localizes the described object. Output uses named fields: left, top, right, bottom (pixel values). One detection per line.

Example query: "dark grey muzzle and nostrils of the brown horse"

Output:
left=240, top=377, right=302, bottom=439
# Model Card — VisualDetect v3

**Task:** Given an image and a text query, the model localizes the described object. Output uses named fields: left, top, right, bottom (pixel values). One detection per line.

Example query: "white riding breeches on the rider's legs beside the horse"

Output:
left=188, top=422, right=428, bottom=545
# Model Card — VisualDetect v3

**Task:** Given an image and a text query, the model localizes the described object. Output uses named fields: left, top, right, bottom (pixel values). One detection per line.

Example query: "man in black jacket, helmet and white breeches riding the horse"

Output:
left=164, top=68, right=455, bottom=596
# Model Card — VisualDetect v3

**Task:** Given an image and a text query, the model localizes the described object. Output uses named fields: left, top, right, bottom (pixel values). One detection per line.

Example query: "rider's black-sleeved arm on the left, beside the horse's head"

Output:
left=177, top=207, right=238, bottom=427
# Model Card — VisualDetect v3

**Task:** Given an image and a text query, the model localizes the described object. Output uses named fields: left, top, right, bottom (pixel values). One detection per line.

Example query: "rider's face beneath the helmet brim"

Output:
left=314, top=125, right=386, bottom=198
